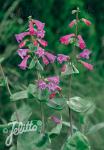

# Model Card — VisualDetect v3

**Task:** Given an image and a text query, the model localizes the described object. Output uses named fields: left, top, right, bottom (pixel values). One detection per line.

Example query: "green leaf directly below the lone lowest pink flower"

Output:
left=49, top=123, right=62, bottom=138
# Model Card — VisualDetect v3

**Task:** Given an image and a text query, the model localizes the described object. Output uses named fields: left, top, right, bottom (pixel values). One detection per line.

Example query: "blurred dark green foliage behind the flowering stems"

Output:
left=0, top=0, right=104, bottom=150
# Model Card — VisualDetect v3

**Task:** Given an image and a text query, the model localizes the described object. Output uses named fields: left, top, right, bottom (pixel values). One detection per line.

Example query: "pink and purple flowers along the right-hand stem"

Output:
left=60, top=18, right=93, bottom=72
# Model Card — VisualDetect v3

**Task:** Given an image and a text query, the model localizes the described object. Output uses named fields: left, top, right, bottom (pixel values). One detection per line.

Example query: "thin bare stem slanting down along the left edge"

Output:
left=0, top=64, right=19, bottom=121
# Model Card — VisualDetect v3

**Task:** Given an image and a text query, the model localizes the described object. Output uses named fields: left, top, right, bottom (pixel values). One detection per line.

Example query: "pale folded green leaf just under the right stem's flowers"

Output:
left=61, top=62, right=79, bottom=76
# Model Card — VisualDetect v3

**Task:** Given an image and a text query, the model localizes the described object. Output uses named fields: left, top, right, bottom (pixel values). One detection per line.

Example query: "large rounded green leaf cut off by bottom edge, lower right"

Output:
left=61, top=132, right=91, bottom=150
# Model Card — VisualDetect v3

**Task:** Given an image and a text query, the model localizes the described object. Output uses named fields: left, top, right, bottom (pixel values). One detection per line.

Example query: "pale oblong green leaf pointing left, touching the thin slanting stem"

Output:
left=10, top=90, right=28, bottom=101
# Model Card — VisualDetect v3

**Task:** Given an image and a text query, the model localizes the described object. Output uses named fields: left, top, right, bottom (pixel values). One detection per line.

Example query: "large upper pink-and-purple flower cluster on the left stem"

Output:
left=15, top=17, right=69, bottom=70
